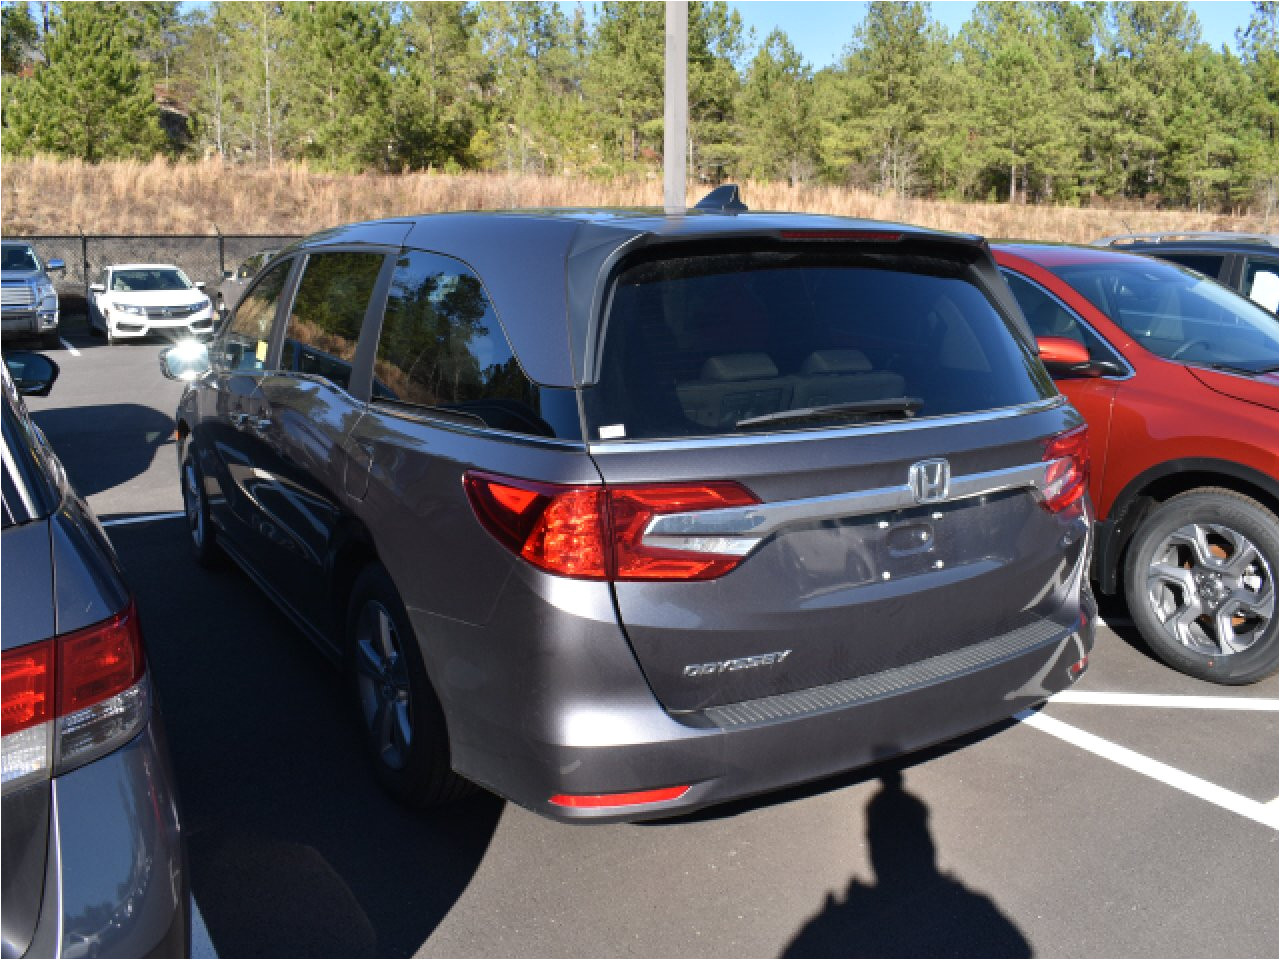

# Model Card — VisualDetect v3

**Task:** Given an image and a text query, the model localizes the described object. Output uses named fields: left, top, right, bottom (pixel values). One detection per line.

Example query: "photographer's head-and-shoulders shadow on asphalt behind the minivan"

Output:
left=783, top=769, right=1032, bottom=957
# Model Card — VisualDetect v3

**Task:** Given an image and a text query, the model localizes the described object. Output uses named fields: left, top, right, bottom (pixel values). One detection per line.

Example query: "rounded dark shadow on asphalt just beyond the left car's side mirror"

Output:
left=31, top=401, right=174, bottom=498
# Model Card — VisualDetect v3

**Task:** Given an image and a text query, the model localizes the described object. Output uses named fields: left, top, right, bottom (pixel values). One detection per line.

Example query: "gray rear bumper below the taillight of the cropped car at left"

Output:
left=27, top=713, right=191, bottom=956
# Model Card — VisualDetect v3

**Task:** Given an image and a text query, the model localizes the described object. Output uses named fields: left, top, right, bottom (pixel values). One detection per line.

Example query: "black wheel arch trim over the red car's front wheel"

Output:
left=1093, top=457, right=1280, bottom=594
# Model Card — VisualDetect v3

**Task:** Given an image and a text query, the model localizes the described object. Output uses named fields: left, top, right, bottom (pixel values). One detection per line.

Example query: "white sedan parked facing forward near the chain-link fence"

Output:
left=88, top=264, right=214, bottom=343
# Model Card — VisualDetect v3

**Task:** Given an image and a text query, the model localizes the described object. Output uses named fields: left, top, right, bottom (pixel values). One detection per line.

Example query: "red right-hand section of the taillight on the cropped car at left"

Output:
left=58, top=602, right=146, bottom=717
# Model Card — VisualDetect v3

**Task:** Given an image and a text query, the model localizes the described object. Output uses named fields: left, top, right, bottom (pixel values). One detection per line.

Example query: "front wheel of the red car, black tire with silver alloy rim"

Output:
left=1124, top=488, right=1280, bottom=685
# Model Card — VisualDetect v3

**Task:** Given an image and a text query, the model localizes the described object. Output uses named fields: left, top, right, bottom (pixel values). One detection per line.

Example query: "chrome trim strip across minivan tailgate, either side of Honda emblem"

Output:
left=644, top=461, right=1053, bottom=557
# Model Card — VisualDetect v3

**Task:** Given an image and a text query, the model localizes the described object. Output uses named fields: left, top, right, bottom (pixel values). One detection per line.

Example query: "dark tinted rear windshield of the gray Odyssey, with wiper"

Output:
left=584, top=247, right=1055, bottom=440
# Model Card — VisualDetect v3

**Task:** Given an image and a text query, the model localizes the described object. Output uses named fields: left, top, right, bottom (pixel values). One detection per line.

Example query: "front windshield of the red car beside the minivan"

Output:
left=1051, top=257, right=1280, bottom=372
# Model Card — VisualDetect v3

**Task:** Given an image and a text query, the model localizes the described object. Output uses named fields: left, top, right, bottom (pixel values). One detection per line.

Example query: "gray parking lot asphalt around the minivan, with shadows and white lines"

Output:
left=12, top=333, right=1280, bottom=957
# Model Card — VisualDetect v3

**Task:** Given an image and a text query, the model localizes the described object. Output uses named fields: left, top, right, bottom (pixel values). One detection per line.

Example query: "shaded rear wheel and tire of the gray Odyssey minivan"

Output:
left=344, top=563, right=475, bottom=810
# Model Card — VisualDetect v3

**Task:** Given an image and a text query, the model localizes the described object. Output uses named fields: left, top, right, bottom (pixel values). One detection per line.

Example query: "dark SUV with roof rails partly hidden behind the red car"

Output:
left=1093, top=232, right=1280, bottom=314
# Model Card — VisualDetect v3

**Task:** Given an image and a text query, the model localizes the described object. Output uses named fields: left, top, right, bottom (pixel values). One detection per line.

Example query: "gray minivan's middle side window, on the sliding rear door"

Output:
left=280, top=253, right=385, bottom=389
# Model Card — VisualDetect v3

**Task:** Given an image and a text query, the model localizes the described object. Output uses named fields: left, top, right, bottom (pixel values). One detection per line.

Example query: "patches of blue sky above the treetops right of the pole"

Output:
left=721, top=0, right=1252, bottom=70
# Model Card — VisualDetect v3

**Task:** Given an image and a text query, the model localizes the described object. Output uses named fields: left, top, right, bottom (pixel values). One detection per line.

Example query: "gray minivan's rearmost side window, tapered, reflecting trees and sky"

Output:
left=374, top=251, right=554, bottom=436
